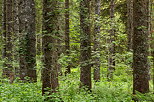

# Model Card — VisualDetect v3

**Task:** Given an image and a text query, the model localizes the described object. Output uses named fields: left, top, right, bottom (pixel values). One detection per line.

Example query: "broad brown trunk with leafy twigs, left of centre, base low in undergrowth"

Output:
left=42, top=0, right=59, bottom=95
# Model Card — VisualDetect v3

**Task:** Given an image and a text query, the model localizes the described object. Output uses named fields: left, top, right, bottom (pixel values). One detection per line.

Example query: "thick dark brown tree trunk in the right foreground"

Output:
left=133, top=0, right=149, bottom=94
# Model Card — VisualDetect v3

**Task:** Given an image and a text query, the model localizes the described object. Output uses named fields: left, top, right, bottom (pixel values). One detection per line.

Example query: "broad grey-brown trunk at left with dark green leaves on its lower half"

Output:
left=19, top=0, right=37, bottom=82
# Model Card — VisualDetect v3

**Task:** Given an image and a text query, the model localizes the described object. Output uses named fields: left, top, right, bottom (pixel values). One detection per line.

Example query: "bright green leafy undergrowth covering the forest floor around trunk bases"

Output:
left=0, top=69, right=154, bottom=102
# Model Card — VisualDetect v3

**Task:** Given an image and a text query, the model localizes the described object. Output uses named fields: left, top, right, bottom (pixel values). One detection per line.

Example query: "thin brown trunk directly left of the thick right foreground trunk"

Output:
left=126, top=0, right=133, bottom=51
